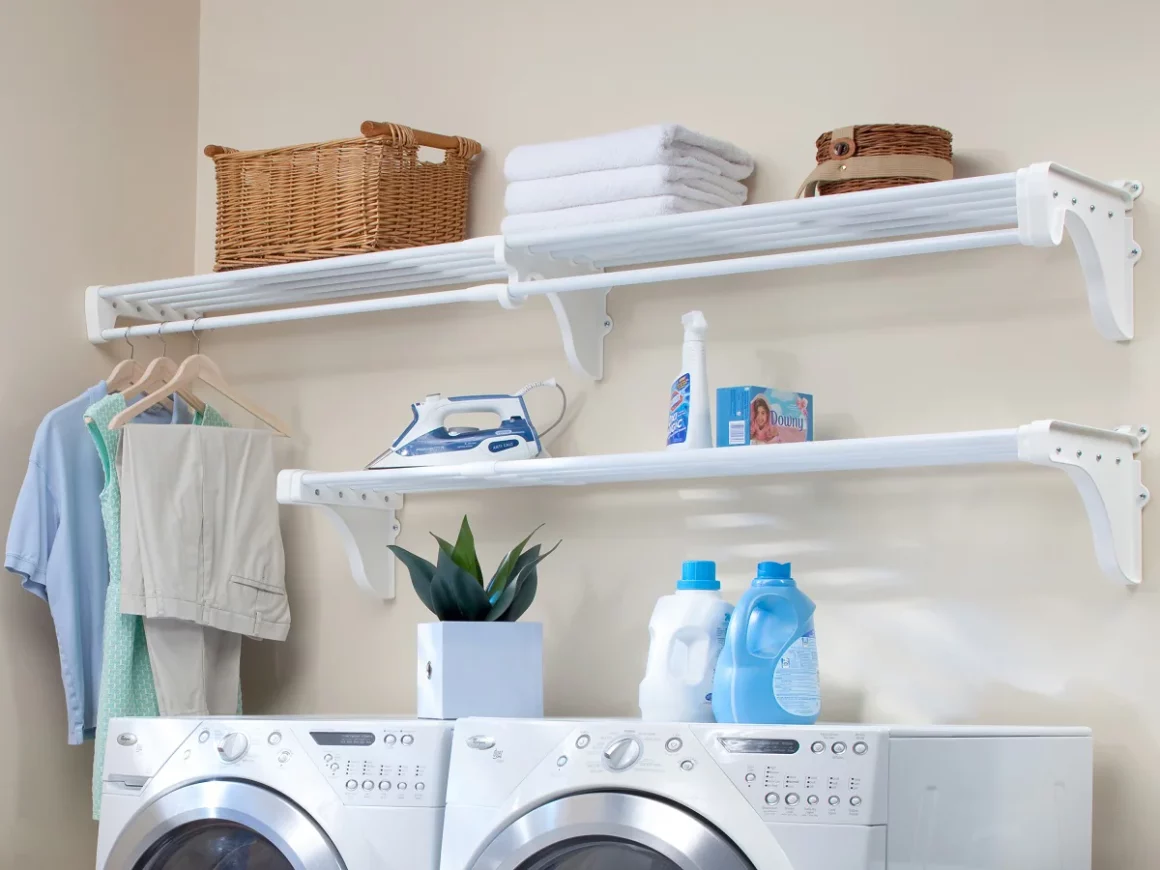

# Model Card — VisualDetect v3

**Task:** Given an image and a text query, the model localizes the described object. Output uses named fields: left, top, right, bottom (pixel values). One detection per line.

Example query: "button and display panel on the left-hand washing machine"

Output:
left=298, top=722, right=450, bottom=806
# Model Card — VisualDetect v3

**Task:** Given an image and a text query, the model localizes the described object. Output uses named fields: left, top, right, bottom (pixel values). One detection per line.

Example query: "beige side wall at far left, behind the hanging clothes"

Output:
left=0, top=0, right=197, bottom=870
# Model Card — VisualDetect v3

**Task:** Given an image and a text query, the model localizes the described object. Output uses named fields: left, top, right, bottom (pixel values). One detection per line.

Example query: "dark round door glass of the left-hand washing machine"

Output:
left=136, top=820, right=293, bottom=870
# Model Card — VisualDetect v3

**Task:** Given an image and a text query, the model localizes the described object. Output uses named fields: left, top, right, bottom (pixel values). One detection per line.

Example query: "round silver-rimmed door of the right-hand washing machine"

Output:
left=473, top=792, right=753, bottom=870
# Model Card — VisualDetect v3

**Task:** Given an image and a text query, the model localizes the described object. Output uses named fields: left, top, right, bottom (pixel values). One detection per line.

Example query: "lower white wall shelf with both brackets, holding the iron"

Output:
left=278, top=420, right=1148, bottom=599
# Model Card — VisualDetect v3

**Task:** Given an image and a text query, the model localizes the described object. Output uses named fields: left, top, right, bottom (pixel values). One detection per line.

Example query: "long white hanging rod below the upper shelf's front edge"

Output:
left=101, top=230, right=1021, bottom=341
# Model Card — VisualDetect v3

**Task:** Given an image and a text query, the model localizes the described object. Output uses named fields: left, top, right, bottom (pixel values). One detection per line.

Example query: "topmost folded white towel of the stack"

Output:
left=503, top=124, right=753, bottom=181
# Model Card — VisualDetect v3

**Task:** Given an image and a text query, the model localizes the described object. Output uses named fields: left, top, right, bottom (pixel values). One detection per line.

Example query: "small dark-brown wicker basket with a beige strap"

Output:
left=798, top=124, right=954, bottom=196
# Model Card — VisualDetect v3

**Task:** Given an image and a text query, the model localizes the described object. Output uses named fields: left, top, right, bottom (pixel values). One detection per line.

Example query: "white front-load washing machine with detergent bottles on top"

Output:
left=441, top=719, right=1092, bottom=870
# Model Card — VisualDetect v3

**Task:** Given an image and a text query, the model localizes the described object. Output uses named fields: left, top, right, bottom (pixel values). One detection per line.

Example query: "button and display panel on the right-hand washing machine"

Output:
left=701, top=726, right=890, bottom=825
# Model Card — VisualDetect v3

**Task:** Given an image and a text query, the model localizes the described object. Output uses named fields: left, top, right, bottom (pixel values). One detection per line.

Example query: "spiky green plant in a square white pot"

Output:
left=391, top=516, right=560, bottom=719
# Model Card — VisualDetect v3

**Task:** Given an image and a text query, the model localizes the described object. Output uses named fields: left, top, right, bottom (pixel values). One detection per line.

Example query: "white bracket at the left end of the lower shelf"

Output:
left=278, top=471, right=403, bottom=601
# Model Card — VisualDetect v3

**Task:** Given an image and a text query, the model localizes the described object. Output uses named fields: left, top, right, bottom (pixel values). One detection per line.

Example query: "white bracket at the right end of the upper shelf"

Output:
left=1016, top=164, right=1144, bottom=341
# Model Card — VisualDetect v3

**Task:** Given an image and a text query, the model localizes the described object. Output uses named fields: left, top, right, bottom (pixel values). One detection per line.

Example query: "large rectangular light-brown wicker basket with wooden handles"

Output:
left=205, top=121, right=481, bottom=271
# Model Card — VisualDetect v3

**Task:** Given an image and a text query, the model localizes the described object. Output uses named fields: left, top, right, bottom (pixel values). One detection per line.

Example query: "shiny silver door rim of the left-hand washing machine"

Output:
left=107, top=780, right=346, bottom=870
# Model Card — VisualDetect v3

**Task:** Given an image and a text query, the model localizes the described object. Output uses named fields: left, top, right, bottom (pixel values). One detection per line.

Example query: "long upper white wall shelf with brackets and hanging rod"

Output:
left=86, top=164, right=1143, bottom=378
